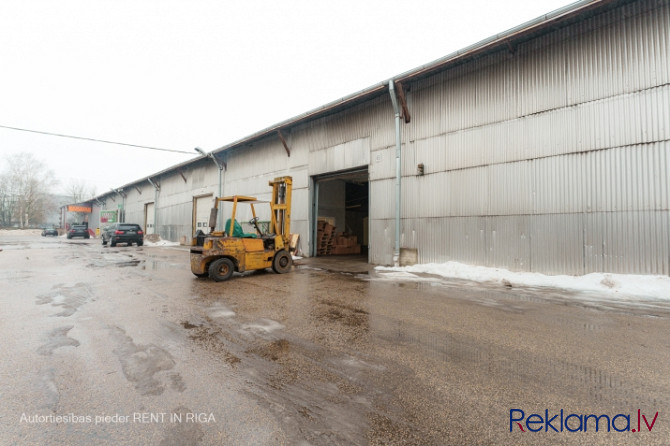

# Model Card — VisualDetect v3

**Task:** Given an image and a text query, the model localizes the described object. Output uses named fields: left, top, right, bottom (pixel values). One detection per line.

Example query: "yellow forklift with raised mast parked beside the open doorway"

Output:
left=191, top=177, right=293, bottom=282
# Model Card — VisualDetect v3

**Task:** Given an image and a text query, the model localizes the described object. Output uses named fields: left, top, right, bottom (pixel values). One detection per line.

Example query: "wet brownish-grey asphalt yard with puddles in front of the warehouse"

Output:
left=0, top=236, right=670, bottom=446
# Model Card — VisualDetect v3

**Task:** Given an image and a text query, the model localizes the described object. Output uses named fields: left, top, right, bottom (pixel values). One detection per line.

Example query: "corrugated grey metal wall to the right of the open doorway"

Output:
left=384, top=1, right=670, bottom=274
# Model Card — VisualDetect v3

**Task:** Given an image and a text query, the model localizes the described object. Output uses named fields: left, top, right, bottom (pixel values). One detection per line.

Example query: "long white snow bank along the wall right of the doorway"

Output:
left=375, top=262, right=670, bottom=300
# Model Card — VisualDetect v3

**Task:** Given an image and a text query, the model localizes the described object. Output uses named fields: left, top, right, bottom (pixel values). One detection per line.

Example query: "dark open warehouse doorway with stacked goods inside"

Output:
left=311, top=168, right=370, bottom=261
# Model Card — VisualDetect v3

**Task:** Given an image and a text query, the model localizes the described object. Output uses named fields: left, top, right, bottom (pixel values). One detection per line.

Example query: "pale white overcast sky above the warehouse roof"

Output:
left=0, top=0, right=571, bottom=194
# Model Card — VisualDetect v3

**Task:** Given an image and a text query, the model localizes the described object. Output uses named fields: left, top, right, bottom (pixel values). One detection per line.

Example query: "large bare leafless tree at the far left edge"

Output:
left=0, top=153, right=57, bottom=228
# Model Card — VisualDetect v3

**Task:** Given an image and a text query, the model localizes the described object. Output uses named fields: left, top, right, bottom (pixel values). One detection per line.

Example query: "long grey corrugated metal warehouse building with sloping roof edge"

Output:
left=90, top=0, right=670, bottom=275
